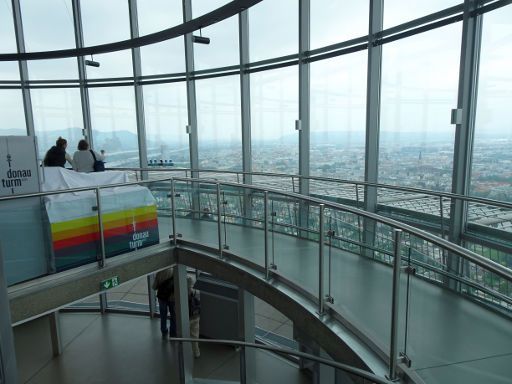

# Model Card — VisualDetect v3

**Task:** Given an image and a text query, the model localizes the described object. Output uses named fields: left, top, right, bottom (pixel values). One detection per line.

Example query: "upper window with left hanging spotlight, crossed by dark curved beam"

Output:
left=80, top=0, right=133, bottom=78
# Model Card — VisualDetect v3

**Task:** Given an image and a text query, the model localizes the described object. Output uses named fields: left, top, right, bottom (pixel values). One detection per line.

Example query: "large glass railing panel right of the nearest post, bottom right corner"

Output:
left=399, top=240, right=512, bottom=383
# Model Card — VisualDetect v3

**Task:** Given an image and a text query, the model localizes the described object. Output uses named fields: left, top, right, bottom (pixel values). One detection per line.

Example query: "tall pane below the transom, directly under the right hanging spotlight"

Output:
left=196, top=76, right=242, bottom=170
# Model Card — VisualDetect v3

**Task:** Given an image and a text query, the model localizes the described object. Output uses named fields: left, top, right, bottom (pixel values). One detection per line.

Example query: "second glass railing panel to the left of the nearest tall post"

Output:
left=269, top=193, right=319, bottom=297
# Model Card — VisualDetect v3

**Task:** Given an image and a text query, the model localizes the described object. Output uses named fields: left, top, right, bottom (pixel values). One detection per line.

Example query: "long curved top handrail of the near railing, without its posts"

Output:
left=0, top=177, right=512, bottom=282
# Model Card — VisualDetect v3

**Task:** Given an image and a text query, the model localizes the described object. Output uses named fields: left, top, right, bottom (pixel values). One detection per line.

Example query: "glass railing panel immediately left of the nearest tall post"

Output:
left=324, top=208, right=394, bottom=351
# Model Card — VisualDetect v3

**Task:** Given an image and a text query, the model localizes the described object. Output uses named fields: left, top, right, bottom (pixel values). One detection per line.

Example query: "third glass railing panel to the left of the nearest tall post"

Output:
left=221, top=187, right=265, bottom=267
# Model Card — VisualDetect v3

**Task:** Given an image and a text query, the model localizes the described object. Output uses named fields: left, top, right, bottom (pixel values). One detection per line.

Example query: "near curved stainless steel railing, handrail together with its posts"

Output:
left=4, top=177, right=512, bottom=379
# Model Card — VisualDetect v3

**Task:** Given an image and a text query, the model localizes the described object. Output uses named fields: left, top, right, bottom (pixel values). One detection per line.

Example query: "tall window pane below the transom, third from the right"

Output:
left=310, top=51, right=368, bottom=180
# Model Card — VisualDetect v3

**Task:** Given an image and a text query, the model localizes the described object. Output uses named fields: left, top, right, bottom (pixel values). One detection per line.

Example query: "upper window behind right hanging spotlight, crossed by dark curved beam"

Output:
left=192, top=0, right=240, bottom=70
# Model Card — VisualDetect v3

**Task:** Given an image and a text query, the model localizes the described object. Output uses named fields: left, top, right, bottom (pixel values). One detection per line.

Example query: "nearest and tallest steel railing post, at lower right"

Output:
left=388, top=229, right=402, bottom=381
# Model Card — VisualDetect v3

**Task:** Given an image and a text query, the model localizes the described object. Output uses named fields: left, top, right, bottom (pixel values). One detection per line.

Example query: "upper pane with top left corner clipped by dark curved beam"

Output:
left=249, top=0, right=299, bottom=61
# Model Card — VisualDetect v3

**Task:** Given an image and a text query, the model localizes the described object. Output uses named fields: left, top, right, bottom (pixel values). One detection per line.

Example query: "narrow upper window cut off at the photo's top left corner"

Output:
left=0, top=1, right=20, bottom=80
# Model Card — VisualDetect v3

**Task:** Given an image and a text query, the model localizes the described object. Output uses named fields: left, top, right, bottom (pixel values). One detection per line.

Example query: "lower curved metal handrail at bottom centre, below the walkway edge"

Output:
left=169, top=337, right=391, bottom=384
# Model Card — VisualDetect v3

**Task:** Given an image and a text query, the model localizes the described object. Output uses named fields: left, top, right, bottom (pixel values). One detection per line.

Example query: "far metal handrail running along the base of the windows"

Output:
left=108, top=167, right=512, bottom=209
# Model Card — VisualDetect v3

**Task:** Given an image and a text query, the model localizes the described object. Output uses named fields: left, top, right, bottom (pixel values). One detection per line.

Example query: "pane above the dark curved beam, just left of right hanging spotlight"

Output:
left=137, top=0, right=183, bottom=36
